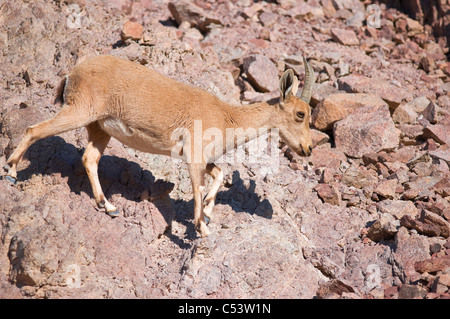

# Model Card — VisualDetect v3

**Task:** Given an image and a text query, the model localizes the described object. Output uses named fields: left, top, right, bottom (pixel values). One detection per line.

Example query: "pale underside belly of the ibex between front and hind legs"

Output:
left=99, top=118, right=171, bottom=155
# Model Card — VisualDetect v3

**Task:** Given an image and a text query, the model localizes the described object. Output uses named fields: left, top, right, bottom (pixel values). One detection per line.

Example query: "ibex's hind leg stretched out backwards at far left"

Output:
left=4, top=105, right=92, bottom=182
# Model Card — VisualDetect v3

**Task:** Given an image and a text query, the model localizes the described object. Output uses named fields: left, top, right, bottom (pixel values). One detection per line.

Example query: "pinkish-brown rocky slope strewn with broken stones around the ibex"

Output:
left=0, top=0, right=450, bottom=298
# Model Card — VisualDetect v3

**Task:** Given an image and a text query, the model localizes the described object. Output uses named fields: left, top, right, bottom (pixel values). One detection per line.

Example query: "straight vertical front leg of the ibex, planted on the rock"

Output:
left=189, top=164, right=210, bottom=237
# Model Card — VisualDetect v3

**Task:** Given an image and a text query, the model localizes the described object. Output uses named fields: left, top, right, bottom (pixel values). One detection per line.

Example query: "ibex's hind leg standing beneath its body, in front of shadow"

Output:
left=82, top=122, right=119, bottom=217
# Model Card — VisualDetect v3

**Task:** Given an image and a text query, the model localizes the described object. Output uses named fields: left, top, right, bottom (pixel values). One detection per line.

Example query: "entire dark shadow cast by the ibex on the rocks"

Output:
left=7, top=136, right=273, bottom=245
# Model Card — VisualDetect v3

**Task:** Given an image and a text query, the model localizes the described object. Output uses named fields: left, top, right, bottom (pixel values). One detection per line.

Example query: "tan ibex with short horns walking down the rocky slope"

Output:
left=4, top=56, right=314, bottom=237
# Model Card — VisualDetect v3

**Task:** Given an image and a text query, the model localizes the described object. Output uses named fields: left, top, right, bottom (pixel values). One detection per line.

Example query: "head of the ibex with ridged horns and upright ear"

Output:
left=278, top=58, right=314, bottom=156
